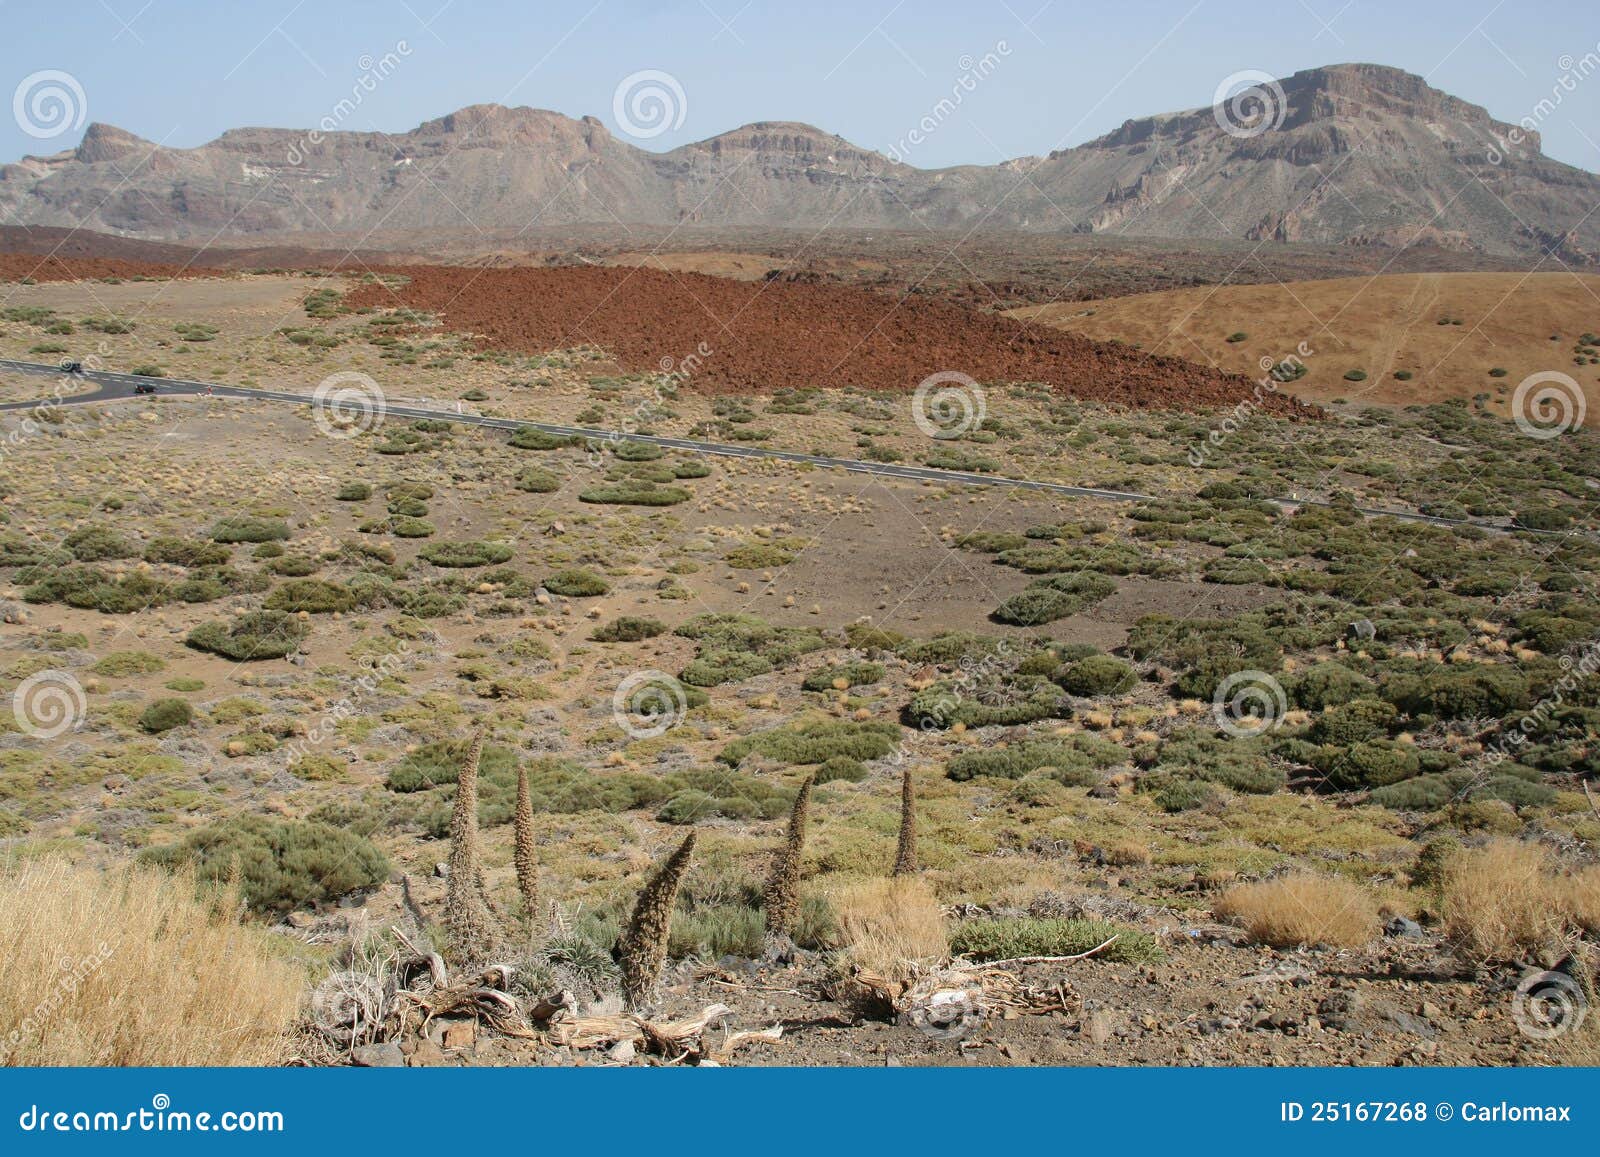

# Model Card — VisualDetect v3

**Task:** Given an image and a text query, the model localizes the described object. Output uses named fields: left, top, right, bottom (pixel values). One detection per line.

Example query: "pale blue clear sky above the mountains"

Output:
left=9, top=0, right=1600, bottom=171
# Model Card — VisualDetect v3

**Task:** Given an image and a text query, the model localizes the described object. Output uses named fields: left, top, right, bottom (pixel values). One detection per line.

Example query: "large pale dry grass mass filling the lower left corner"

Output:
left=0, top=858, right=304, bottom=1066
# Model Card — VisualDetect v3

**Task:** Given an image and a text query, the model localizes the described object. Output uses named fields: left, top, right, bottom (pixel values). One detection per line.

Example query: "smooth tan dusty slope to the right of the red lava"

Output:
left=1011, top=272, right=1600, bottom=413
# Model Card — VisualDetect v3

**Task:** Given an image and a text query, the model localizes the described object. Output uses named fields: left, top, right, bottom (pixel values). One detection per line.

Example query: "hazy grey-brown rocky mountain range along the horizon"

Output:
left=0, top=64, right=1600, bottom=262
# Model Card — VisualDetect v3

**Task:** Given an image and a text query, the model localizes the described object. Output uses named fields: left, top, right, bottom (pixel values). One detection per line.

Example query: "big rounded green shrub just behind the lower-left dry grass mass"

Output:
left=144, top=816, right=389, bottom=915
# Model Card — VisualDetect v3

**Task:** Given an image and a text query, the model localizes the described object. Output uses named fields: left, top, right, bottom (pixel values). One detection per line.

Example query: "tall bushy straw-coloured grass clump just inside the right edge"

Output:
left=1440, top=840, right=1568, bottom=962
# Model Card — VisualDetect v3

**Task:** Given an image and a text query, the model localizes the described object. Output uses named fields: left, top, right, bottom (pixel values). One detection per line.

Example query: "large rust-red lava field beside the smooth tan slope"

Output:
left=349, top=266, right=1307, bottom=416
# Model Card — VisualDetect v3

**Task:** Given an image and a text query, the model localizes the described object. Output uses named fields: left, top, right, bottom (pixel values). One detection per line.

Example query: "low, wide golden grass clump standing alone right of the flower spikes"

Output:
left=1214, top=872, right=1378, bottom=947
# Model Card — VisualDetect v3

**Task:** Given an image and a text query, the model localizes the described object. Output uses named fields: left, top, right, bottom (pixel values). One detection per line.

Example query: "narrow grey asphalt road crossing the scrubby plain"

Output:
left=0, top=358, right=1557, bottom=534
